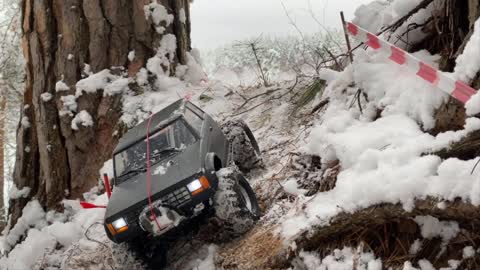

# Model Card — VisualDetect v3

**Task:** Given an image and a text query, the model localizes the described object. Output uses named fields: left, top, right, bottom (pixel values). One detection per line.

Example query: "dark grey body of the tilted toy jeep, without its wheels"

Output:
left=105, top=100, right=229, bottom=243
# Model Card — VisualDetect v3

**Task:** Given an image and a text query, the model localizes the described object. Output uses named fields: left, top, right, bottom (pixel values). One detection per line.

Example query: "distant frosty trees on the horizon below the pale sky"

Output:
left=205, top=31, right=343, bottom=83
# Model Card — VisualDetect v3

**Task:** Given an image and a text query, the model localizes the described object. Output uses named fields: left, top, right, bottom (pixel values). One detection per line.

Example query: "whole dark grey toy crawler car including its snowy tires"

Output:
left=105, top=99, right=260, bottom=258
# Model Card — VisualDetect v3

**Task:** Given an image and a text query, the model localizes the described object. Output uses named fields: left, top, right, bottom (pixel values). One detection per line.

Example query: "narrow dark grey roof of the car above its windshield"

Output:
left=113, top=99, right=189, bottom=154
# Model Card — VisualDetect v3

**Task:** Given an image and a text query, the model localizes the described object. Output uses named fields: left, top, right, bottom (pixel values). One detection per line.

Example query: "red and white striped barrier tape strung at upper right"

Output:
left=347, top=22, right=477, bottom=104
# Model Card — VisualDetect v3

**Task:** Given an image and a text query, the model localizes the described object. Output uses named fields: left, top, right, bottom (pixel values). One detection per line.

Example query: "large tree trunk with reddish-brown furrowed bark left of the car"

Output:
left=10, top=0, right=190, bottom=222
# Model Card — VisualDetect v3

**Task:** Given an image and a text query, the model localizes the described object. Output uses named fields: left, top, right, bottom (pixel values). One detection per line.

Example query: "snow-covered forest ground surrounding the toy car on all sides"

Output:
left=0, top=0, right=480, bottom=270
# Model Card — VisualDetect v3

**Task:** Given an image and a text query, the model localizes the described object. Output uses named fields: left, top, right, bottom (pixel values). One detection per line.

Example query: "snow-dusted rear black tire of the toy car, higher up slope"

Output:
left=222, top=120, right=261, bottom=172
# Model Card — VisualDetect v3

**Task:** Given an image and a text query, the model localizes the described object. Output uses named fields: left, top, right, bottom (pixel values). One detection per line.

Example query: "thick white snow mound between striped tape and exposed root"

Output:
left=281, top=63, right=480, bottom=239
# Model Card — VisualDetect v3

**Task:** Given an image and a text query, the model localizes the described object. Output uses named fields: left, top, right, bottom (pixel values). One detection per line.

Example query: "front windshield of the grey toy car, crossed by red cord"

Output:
left=115, top=118, right=196, bottom=184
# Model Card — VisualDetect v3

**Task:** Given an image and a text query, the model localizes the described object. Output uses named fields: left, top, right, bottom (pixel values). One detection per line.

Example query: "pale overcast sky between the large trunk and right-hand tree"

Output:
left=191, top=0, right=372, bottom=49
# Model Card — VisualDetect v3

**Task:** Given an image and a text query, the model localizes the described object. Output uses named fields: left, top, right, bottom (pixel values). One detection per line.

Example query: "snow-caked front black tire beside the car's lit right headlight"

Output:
left=213, top=166, right=260, bottom=238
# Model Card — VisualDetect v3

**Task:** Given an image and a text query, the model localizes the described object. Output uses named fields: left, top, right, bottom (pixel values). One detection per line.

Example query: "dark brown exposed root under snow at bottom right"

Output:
left=267, top=199, right=480, bottom=269
